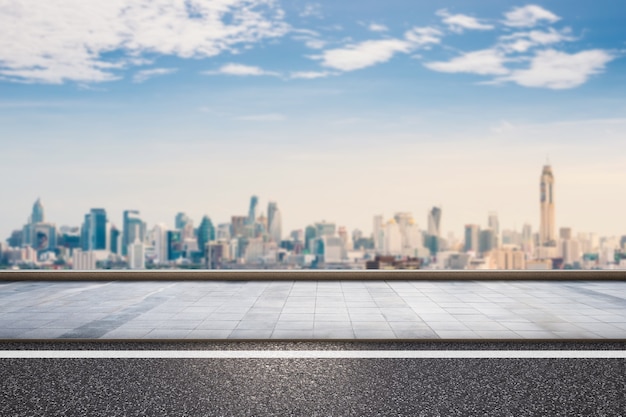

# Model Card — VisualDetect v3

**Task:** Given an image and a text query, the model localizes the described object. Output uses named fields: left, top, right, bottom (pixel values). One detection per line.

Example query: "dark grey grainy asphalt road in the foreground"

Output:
left=0, top=342, right=626, bottom=416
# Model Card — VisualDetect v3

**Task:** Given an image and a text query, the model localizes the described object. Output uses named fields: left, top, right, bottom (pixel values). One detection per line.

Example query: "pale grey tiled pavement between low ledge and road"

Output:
left=0, top=281, right=626, bottom=339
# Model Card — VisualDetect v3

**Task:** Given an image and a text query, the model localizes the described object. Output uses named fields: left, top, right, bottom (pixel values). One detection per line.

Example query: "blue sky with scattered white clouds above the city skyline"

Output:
left=0, top=0, right=626, bottom=240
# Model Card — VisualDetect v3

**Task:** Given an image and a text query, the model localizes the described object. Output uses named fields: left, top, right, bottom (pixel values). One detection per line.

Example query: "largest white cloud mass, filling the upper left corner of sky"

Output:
left=0, top=0, right=288, bottom=83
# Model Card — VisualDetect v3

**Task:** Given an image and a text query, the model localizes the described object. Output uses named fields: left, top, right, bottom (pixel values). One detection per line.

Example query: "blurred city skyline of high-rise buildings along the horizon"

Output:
left=0, top=165, right=626, bottom=270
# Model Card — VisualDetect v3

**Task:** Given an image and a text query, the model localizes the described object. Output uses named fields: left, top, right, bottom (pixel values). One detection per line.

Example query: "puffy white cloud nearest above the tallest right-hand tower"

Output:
left=495, top=49, right=615, bottom=90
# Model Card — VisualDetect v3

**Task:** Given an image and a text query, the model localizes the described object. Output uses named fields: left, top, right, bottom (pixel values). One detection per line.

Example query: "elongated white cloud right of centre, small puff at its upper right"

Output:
left=312, top=27, right=441, bottom=71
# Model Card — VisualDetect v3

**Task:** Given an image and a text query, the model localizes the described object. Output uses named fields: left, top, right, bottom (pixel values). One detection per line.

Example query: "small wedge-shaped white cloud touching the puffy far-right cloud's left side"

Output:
left=424, top=49, right=509, bottom=75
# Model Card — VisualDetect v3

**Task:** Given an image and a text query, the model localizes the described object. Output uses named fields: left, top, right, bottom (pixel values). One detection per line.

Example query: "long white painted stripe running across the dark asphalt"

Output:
left=0, top=350, right=626, bottom=359
